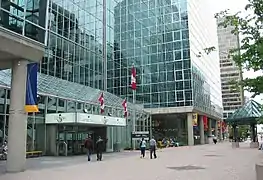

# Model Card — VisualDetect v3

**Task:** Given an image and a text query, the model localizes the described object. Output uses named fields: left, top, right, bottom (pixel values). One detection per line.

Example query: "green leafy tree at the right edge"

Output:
left=207, top=0, right=263, bottom=97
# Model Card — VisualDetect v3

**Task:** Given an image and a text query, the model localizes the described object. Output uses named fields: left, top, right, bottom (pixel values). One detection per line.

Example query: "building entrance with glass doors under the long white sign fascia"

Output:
left=45, top=113, right=126, bottom=156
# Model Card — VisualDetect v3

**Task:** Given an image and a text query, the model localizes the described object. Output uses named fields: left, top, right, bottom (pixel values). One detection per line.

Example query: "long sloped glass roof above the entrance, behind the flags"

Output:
left=0, top=69, right=143, bottom=111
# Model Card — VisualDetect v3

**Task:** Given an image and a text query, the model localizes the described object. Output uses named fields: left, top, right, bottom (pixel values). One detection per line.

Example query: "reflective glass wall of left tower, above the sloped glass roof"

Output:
left=40, top=0, right=103, bottom=89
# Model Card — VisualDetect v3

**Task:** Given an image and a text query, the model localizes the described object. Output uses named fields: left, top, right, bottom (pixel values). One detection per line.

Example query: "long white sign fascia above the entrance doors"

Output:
left=46, top=113, right=126, bottom=126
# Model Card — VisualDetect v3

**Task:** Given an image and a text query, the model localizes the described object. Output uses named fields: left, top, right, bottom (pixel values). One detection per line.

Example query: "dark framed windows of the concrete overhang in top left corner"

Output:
left=0, top=0, right=49, bottom=44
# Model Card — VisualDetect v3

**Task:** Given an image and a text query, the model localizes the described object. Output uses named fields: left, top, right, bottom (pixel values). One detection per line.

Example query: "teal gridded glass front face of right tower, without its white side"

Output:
left=108, top=0, right=192, bottom=108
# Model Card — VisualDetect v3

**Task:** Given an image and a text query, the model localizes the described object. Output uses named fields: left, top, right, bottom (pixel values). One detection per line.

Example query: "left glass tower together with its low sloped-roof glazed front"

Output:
left=0, top=0, right=150, bottom=155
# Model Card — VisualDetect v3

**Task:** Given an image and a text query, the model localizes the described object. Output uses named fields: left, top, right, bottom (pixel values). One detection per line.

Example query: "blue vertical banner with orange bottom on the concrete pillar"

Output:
left=25, top=63, right=39, bottom=113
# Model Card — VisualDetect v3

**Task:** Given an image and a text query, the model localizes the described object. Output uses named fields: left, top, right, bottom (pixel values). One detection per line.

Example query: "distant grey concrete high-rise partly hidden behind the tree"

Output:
left=217, top=19, right=245, bottom=119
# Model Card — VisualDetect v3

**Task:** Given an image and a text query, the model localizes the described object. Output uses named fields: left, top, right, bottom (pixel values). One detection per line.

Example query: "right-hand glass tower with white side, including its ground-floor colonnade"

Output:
left=107, top=0, right=223, bottom=145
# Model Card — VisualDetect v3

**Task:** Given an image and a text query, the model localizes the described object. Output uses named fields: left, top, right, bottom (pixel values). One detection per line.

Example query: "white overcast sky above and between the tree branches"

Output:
left=211, top=0, right=263, bottom=103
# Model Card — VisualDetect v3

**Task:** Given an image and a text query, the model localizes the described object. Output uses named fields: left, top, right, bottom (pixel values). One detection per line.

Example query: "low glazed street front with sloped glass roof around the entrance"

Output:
left=0, top=70, right=150, bottom=153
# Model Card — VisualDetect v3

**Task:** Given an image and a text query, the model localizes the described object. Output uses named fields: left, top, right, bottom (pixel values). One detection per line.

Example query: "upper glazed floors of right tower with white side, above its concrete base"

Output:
left=108, top=0, right=222, bottom=116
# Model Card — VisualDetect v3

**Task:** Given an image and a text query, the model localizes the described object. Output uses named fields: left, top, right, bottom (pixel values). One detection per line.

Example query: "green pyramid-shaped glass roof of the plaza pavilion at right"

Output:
left=226, top=100, right=263, bottom=125
